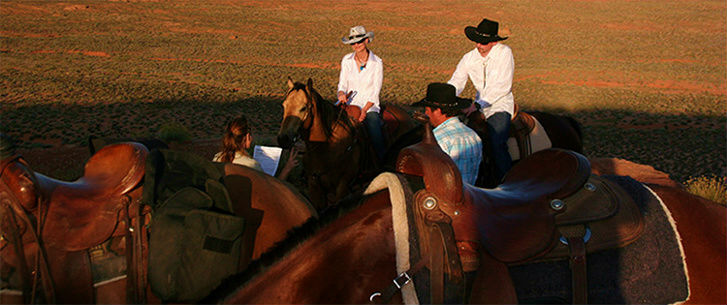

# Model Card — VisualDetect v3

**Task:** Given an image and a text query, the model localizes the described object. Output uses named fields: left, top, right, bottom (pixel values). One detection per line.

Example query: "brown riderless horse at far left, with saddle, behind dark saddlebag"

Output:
left=0, top=138, right=317, bottom=303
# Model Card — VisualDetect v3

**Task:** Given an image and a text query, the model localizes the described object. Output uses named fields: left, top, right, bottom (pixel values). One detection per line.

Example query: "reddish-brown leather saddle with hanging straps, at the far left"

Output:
left=0, top=143, right=148, bottom=303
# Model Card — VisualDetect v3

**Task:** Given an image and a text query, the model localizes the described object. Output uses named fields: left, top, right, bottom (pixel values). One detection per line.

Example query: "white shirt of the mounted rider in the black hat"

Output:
left=448, top=43, right=515, bottom=117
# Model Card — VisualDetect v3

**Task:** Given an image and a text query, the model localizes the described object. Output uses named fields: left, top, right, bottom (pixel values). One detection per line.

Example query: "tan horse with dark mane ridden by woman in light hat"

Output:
left=278, top=78, right=418, bottom=210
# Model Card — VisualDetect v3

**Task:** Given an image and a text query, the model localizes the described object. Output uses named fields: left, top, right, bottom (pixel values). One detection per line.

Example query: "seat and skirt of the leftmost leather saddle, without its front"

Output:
left=35, top=142, right=149, bottom=251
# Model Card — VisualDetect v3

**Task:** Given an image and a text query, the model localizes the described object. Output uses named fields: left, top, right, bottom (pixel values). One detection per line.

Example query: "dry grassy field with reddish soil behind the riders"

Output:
left=0, top=0, right=727, bottom=181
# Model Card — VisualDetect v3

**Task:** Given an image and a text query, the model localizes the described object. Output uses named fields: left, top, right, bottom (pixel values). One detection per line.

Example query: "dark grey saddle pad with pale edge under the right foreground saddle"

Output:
left=510, top=176, right=689, bottom=304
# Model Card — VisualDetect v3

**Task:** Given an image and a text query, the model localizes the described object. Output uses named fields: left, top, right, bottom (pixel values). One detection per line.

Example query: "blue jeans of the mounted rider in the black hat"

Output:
left=487, top=112, right=512, bottom=181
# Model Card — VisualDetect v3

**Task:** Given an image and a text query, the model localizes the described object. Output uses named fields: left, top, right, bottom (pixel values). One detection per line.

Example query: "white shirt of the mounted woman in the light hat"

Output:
left=338, top=50, right=384, bottom=112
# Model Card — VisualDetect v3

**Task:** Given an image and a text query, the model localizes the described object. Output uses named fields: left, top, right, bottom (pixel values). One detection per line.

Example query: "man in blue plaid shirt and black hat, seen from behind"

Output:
left=412, top=83, right=482, bottom=185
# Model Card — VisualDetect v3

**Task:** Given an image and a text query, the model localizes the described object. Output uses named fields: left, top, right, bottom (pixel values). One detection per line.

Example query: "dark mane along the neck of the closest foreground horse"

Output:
left=200, top=189, right=375, bottom=304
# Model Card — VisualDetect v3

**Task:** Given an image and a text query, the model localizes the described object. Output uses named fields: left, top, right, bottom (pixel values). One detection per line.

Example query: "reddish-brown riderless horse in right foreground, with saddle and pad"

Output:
left=204, top=124, right=727, bottom=304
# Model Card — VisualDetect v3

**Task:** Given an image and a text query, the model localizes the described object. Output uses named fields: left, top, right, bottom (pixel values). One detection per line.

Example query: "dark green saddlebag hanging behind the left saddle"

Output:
left=144, top=150, right=250, bottom=303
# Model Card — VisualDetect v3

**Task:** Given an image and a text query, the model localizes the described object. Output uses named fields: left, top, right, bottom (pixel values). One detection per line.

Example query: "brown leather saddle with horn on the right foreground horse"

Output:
left=396, top=121, right=643, bottom=303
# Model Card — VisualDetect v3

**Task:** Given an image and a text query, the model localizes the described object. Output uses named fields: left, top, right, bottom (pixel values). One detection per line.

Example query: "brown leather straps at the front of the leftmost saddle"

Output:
left=0, top=155, right=56, bottom=304
